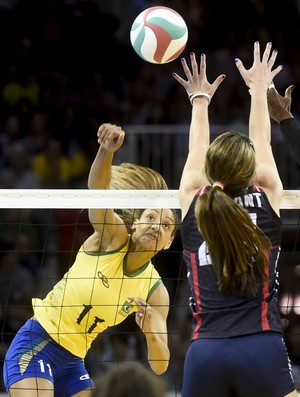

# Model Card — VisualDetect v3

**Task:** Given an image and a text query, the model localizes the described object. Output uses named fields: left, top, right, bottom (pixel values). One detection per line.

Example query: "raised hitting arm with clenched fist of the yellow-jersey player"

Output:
left=88, top=123, right=127, bottom=250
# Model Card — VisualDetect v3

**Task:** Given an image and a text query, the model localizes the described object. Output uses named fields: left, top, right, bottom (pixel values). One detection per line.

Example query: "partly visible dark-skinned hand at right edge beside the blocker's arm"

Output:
left=267, top=84, right=295, bottom=123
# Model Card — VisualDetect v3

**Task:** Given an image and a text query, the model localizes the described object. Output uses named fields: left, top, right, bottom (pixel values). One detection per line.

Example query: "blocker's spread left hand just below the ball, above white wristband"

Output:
left=173, top=52, right=226, bottom=103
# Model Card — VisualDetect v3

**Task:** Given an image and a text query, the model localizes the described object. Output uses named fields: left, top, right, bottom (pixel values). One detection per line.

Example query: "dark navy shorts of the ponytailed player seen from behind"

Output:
left=181, top=332, right=295, bottom=397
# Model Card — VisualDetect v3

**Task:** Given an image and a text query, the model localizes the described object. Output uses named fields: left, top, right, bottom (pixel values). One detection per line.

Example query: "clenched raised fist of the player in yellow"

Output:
left=97, top=123, right=125, bottom=152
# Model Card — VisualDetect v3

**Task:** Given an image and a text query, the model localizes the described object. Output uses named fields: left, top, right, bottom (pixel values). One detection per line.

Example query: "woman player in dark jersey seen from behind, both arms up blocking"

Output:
left=174, top=42, right=297, bottom=397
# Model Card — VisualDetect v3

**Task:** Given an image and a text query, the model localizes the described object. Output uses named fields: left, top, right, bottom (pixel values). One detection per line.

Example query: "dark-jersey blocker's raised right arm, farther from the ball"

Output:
left=235, top=42, right=282, bottom=214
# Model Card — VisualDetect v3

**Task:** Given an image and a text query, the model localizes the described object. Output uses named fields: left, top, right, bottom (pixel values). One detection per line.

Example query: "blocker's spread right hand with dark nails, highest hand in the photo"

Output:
left=235, top=41, right=282, bottom=92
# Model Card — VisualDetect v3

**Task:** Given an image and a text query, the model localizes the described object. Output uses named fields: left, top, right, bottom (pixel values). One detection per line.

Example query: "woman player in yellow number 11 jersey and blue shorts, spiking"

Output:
left=4, top=124, right=177, bottom=397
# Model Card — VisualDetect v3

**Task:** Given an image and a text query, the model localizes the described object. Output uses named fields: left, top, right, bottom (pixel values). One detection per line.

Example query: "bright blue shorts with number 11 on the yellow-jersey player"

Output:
left=3, top=319, right=94, bottom=397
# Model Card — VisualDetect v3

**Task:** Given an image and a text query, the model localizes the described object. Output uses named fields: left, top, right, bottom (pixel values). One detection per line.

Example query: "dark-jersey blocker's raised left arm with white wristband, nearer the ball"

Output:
left=173, top=53, right=226, bottom=218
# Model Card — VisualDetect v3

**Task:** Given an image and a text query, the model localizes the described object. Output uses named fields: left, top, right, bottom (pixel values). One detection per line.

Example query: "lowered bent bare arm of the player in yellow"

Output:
left=129, top=284, right=170, bottom=375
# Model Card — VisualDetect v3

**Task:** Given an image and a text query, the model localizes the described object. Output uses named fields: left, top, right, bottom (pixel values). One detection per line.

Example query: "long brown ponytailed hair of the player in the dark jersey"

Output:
left=195, top=132, right=271, bottom=295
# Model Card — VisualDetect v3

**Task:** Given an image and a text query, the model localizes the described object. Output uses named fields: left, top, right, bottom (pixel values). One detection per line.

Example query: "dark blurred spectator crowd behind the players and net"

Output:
left=0, top=0, right=300, bottom=389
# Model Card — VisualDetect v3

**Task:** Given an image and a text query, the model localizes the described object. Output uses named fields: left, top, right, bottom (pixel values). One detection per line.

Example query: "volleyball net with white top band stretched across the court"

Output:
left=0, top=189, right=300, bottom=396
